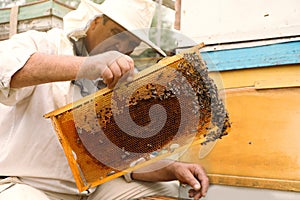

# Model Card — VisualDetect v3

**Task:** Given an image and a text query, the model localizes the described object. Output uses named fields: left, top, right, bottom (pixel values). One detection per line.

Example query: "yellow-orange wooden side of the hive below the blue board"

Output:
left=181, top=65, right=300, bottom=191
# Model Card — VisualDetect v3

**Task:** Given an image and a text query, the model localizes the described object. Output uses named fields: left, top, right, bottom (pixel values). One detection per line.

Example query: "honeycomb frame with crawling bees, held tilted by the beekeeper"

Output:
left=45, top=46, right=230, bottom=191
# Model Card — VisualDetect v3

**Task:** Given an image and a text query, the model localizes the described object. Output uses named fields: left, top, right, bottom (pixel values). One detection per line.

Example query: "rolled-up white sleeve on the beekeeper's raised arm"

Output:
left=0, top=30, right=64, bottom=105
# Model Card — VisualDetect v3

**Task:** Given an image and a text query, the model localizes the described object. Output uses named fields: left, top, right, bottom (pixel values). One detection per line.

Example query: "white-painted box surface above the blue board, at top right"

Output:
left=181, top=0, right=300, bottom=44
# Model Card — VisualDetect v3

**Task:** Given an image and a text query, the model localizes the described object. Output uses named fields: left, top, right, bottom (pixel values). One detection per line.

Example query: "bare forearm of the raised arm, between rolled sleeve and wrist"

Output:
left=10, top=53, right=85, bottom=88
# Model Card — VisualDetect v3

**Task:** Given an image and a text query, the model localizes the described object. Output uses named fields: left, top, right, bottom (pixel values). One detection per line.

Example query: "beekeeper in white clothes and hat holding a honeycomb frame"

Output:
left=0, top=0, right=209, bottom=200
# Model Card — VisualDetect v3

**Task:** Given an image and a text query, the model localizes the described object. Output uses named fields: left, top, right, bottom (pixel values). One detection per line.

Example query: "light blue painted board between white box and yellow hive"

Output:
left=201, top=41, right=300, bottom=71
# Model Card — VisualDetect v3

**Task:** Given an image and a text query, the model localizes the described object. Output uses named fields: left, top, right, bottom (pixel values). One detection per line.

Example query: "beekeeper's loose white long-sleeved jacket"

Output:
left=0, top=0, right=101, bottom=194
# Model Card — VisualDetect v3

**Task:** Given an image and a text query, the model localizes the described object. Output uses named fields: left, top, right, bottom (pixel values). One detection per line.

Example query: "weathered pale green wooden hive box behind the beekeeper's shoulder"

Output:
left=0, top=0, right=74, bottom=40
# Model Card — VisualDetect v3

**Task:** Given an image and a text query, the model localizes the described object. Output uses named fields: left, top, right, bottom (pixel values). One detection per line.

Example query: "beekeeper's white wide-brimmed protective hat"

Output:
left=64, top=0, right=166, bottom=56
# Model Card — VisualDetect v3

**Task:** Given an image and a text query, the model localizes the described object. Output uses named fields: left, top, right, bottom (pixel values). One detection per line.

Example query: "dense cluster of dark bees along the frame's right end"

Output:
left=178, top=52, right=231, bottom=144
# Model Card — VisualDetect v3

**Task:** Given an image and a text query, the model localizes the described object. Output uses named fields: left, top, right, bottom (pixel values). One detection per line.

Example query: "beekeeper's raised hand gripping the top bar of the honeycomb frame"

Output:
left=78, top=51, right=134, bottom=88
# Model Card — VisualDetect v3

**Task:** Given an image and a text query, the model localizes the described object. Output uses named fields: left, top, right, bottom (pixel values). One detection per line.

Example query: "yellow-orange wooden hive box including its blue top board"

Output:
left=181, top=41, right=300, bottom=192
